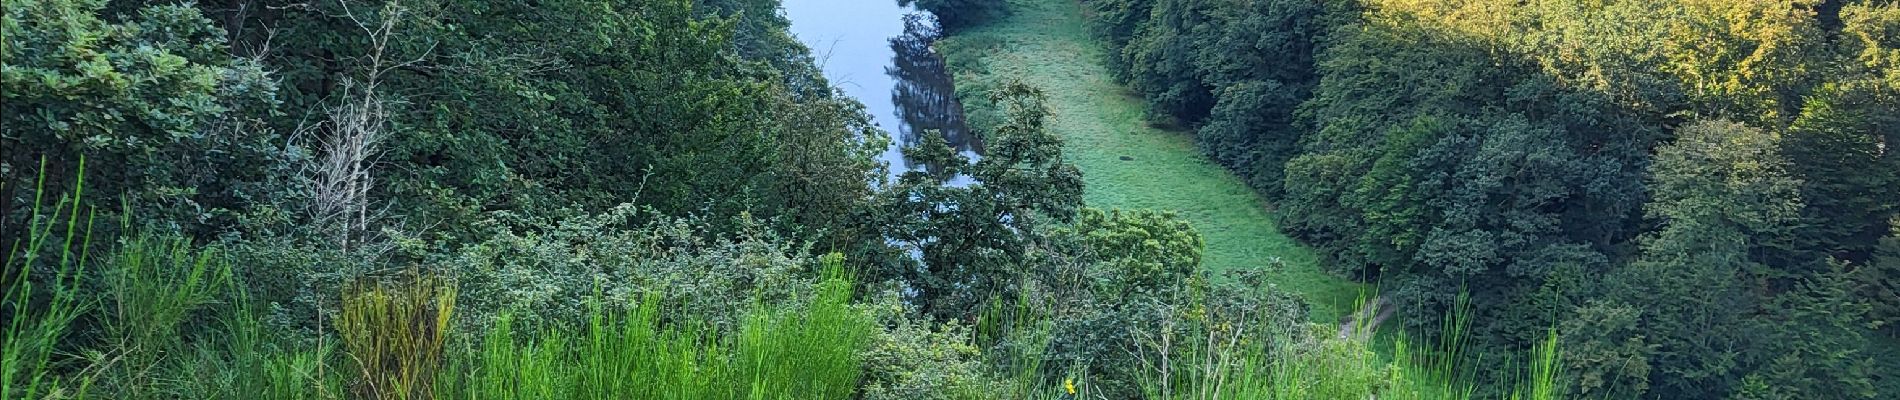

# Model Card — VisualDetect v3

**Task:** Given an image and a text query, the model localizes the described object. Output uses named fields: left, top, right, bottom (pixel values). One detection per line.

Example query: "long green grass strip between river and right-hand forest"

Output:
left=939, top=0, right=1364, bottom=322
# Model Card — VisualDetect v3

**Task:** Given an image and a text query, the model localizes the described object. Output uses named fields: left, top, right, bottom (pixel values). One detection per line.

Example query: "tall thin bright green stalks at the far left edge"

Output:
left=0, top=159, right=93, bottom=398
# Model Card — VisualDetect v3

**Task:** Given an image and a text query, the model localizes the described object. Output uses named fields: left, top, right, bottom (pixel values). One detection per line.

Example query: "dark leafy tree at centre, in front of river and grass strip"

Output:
left=876, top=82, right=1083, bottom=317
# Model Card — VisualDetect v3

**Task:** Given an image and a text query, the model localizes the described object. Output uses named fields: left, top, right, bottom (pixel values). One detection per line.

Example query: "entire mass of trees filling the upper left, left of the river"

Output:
left=0, top=0, right=884, bottom=252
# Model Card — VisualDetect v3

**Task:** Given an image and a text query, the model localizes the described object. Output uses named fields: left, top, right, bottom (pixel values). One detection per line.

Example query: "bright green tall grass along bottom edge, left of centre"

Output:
left=437, top=256, right=876, bottom=400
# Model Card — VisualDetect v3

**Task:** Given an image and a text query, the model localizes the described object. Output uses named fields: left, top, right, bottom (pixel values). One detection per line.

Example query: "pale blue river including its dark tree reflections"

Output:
left=785, top=0, right=982, bottom=186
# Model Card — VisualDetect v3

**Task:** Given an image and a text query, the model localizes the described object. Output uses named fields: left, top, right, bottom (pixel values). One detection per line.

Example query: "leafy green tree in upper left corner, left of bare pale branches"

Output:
left=0, top=0, right=285, bottom=237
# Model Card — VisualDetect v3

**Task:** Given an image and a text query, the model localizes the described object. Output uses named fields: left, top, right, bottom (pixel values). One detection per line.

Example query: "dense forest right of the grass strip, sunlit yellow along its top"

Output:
left=1085, top=0, right=1900, bottom=398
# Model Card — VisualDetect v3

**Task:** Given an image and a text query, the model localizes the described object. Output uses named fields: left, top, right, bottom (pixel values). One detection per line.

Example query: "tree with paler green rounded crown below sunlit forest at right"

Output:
left=1609, top=121, right=1801, bottom=398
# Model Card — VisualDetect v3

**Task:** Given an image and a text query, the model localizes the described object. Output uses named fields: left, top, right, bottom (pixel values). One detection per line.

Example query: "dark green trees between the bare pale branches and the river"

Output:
left=178, top=0, right=882, bottom=243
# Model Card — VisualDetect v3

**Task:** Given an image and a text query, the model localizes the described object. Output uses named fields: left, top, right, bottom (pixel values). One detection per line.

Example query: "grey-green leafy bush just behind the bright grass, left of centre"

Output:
left=440, top=205, right=815, bottom=332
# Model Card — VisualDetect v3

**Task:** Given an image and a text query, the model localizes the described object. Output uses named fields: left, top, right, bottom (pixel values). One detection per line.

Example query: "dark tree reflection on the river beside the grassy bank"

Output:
left=884, top=11, right=982, bottom=180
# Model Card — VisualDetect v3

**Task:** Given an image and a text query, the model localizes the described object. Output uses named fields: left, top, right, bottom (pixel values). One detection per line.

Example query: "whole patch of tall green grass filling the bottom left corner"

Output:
left=0, top=159, right=340, bottom=400
